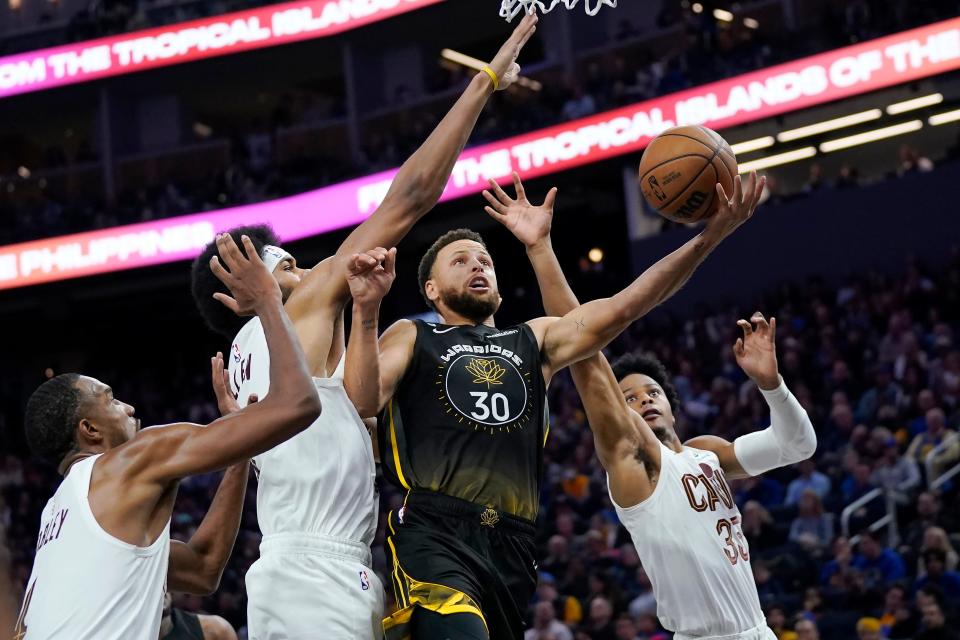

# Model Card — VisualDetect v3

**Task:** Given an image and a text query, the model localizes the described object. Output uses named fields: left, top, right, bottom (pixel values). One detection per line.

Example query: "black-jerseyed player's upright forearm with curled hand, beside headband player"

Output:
left=343, top=247, right=397, bottom=418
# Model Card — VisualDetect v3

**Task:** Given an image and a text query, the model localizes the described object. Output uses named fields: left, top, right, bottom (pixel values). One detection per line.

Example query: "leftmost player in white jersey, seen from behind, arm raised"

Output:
left=14, top=236, right=321, bottom=640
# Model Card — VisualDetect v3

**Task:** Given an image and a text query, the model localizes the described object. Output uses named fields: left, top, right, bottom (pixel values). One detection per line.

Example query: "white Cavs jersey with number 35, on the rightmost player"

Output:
left=611, top=444, right=764, bottom=636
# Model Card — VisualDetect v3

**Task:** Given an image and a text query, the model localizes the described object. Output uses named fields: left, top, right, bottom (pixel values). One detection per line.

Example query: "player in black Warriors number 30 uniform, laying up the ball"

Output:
left=345, top=171, right=762, bottom=640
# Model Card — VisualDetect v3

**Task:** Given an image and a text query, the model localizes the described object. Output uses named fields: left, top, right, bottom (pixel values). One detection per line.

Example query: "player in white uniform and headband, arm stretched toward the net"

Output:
left=193, top=15, right=537, bottom=640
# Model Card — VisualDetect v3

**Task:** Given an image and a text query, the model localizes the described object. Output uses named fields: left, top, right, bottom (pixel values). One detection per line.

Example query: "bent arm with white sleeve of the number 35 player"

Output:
left=686, top=311, right=817, bottom=478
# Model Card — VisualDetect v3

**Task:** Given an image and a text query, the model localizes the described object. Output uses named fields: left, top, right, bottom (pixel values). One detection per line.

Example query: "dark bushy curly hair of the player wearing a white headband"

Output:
left=190, top=224, right=280, bottom=339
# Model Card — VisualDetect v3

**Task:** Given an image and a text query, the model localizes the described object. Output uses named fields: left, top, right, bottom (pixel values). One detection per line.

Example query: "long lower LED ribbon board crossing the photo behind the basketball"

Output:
left=0, top=18, right=960, bottom=289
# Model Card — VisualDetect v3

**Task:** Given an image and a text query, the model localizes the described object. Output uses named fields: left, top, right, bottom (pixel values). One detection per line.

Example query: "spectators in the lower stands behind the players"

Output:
left=0, top=238, right=960, bottom=640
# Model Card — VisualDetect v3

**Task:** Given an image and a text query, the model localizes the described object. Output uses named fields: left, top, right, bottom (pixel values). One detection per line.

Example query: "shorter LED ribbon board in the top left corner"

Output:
left=0, top=0, right=443, bottom=98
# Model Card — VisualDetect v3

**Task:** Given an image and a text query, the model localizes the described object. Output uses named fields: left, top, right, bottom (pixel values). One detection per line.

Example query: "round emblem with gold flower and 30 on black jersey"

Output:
left=437, top=352, right=534, bottom=435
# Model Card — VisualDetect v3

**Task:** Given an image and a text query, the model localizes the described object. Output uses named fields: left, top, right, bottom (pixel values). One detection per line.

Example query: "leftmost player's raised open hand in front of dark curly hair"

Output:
left=210, top=233, right=283, bottom=316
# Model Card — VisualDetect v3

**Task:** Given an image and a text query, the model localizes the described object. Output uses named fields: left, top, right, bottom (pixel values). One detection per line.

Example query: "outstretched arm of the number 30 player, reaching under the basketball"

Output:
left=531, top=173, right=765, bottom=378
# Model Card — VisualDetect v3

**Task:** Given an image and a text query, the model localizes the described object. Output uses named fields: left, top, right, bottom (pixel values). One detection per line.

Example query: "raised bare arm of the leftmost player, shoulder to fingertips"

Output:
left=125, top=234, right=320, bottom=483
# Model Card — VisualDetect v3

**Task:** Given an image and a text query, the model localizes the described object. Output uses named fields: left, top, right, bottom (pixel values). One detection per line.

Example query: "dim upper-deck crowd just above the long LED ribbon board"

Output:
left=0, top=0, right=960, bottom=244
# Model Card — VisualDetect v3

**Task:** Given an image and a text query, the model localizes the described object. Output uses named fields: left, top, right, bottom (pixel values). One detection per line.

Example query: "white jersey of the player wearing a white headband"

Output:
left=230, top=318, right=377, bottom=546
